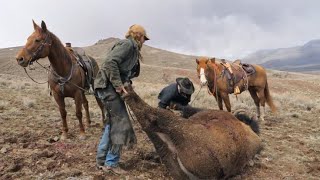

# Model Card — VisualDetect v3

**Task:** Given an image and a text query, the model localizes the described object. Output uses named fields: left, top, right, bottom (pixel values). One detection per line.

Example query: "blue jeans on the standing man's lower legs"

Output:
left=96, top=124, right=120, bottom=167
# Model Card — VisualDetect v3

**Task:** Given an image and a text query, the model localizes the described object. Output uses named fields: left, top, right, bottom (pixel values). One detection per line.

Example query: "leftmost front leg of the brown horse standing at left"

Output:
left=53, top=93, right=68, bottom=140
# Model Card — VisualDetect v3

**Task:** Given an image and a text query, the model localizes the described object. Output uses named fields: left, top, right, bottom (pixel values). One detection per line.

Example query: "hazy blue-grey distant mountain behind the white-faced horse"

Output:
left=243, top=39, right=320, bottom=72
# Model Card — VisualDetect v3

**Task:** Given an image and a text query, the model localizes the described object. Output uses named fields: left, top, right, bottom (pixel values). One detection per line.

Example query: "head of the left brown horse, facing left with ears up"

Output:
left=16, top=21, right=52, bottom=67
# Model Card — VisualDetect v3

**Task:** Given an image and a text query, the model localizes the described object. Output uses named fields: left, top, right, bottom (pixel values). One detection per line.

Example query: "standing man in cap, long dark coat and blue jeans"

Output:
left=94, top=24, right=149, bottom=174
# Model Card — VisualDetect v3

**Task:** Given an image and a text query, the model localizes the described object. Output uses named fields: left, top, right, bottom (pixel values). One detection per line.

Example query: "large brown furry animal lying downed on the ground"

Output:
left=124, top=86, right=261, bottom=179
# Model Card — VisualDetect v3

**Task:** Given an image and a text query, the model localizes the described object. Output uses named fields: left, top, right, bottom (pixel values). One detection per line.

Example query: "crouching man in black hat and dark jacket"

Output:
left=158, top=77, right=194, bottom=109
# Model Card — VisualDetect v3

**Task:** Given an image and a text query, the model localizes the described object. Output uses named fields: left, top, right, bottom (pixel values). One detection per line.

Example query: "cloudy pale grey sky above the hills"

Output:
left=0, top=0, right=320, bottom=58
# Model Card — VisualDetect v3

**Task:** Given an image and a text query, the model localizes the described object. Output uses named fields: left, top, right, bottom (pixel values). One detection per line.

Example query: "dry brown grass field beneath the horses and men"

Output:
left=0, top=41, right=320, bottom=179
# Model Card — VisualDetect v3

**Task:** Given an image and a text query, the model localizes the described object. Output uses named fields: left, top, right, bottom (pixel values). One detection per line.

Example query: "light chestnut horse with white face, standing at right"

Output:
left=196, top=57, right=276, bottom=121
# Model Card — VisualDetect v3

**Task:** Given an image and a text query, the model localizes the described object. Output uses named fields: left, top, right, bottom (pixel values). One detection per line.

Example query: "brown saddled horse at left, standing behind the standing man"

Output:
left=16, top=21, right=104, bottom=139
